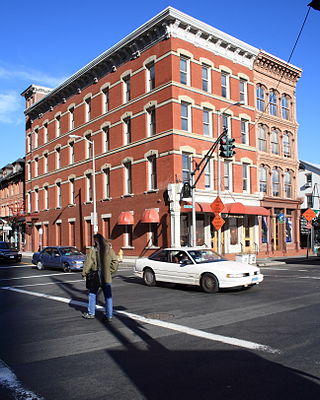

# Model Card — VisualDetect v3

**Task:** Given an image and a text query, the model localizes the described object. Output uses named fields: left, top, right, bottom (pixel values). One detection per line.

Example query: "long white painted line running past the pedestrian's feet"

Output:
left=0, top=286, right=279, bottom=354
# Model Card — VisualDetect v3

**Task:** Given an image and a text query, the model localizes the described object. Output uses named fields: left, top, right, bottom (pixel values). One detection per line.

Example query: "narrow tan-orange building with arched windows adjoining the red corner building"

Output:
left=254, top=51, right=301, bottom=254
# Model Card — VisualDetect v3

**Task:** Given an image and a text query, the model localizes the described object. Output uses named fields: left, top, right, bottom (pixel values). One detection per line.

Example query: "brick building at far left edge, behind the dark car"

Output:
left=0, top=158, right=25, bottom=249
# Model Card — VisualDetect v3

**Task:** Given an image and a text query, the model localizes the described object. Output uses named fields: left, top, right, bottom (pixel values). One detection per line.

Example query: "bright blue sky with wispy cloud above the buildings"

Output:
left=0, top=0, right=320, bottom=167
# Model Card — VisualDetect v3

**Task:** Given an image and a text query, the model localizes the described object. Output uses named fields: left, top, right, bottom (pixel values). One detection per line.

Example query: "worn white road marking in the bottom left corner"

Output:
left=0, top=360, right=44, bottom=400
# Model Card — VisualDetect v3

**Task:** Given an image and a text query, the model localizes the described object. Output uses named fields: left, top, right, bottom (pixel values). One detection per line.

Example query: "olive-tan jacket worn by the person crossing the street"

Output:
left=82, top=247, right=119, bottom=283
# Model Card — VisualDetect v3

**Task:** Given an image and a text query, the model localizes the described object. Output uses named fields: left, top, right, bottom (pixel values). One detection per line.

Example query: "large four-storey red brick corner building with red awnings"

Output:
left=22, top=7, right=300, bottom=256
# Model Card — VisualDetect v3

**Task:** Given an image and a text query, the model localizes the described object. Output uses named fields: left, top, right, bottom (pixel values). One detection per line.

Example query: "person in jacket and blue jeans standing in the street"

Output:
left=82, top=233, right=118, bottom=322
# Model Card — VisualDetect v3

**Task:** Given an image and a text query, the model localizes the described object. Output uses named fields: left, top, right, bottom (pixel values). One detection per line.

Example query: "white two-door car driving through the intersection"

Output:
left=133, top=247, right=263, bottom=293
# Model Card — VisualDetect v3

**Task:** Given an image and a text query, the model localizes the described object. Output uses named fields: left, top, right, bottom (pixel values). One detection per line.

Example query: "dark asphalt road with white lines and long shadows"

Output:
left=0, top=263, right=320, bottom=400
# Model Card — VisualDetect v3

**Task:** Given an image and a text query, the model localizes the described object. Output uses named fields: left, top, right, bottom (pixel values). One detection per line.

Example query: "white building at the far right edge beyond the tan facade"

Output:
left=298, top=160, right=320, bottom=251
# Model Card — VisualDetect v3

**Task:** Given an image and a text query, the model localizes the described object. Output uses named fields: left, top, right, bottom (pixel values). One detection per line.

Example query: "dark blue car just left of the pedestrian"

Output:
left=32, top=246, right=86, bottom=272
